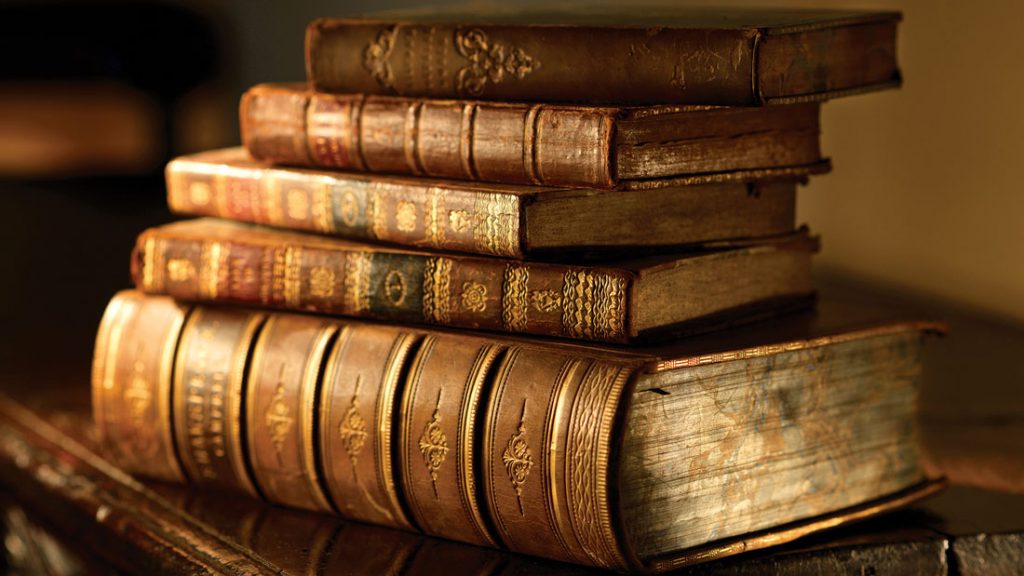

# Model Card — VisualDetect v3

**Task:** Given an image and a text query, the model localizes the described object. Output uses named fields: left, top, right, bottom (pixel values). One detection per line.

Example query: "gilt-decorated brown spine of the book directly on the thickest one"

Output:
left=132, top=229, right=632, bottom=342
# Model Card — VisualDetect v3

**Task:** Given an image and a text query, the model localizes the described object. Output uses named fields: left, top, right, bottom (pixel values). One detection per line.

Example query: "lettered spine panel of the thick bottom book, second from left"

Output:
left=171, top=308, right=266, bottom=496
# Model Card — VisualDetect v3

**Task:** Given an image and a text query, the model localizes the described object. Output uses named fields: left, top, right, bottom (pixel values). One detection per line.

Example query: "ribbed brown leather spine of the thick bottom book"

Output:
left=93, top=292, right=635, bottom=570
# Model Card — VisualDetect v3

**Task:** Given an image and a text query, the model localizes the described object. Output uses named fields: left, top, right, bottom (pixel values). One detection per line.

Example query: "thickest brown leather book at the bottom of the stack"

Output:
left=93, top=291, right=943, bottom=571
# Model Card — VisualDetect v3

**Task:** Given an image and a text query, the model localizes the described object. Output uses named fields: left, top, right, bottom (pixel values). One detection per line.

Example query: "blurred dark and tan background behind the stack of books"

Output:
left=0, top=0, right=1024, bottom=378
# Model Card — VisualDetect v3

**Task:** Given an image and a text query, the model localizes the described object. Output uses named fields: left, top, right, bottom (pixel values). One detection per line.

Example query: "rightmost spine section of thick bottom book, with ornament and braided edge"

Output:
left=481, top=347, right=632, bottom=571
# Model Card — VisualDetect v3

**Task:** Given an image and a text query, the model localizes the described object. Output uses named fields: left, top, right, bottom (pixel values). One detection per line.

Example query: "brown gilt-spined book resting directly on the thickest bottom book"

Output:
left=131, top=216, right=817, bottom=342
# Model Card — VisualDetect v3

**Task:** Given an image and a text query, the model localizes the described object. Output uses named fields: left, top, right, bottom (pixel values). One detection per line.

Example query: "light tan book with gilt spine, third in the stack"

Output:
left=167, top=148, right=798, bottom=258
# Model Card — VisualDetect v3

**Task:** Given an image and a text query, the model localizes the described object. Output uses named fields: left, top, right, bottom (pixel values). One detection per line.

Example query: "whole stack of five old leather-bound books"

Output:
left=93, top=9, right=942, bottom=571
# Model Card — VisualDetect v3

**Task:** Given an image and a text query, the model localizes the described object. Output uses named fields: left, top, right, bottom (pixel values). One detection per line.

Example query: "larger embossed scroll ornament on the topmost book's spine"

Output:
left=455, top=28, right=541, bottom=96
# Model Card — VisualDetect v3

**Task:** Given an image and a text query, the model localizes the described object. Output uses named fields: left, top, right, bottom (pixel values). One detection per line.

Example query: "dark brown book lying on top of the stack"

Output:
left=306, top=3, right=900, bottom=106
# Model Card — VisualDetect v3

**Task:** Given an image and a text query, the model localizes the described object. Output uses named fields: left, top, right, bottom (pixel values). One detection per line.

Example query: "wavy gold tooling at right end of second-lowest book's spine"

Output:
left=561, top=271, right=626, bottom=340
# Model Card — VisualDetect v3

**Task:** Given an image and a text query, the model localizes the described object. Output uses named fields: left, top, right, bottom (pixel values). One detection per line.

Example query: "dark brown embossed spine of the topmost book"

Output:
left=306, top=19, right=760, bottom=106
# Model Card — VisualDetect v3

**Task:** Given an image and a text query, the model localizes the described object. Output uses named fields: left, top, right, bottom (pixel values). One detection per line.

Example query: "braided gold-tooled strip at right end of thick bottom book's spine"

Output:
left=565, top=363, right=630, bottom=569
